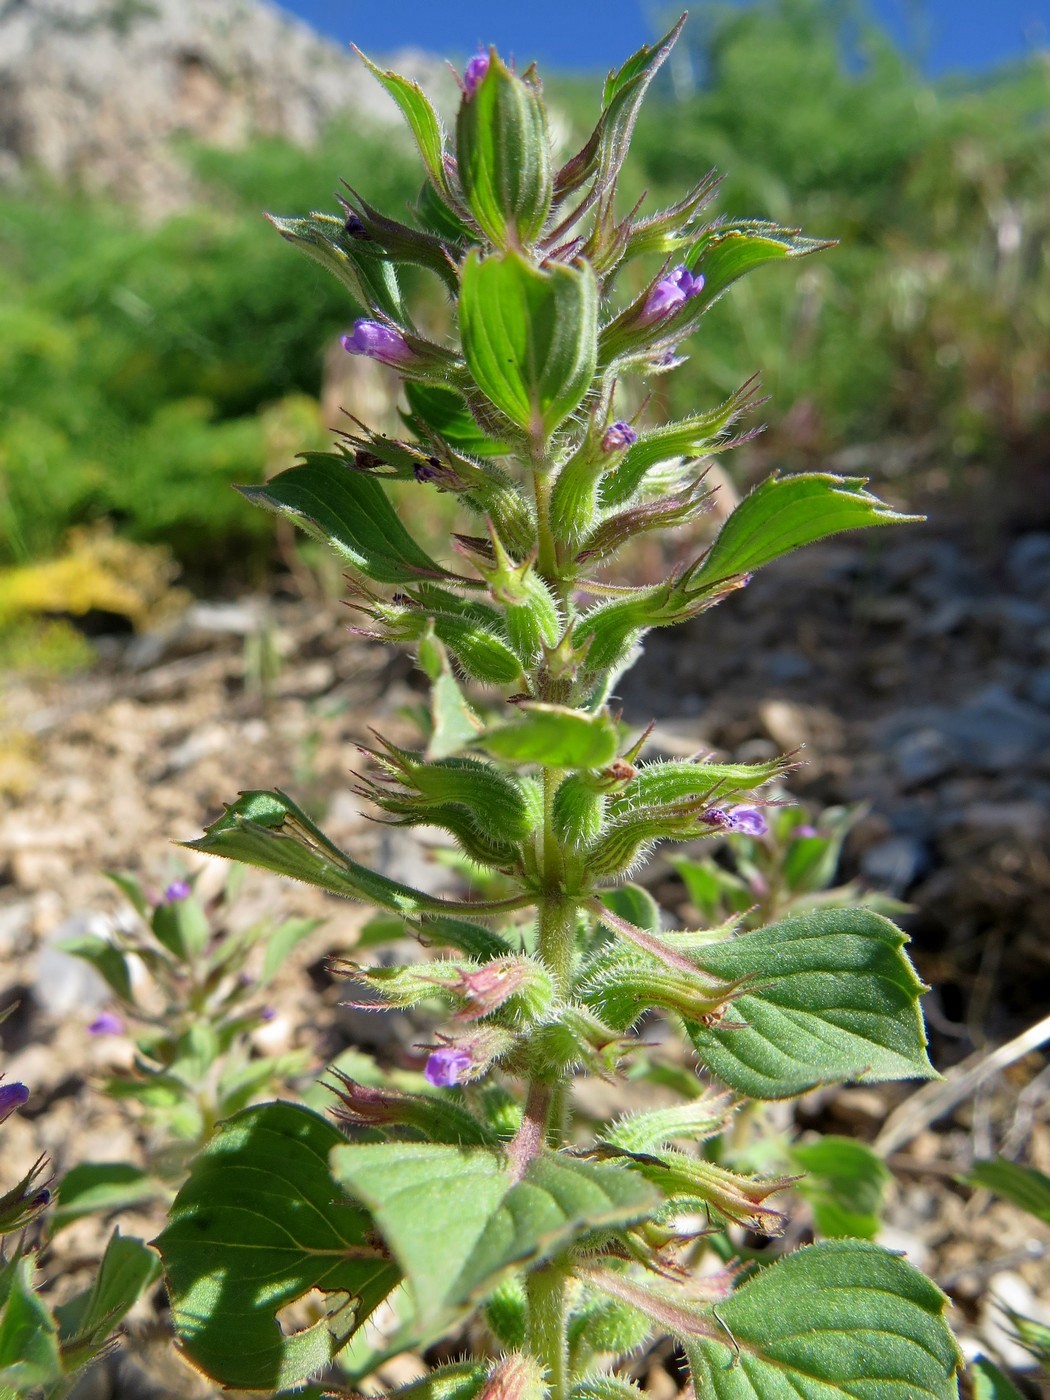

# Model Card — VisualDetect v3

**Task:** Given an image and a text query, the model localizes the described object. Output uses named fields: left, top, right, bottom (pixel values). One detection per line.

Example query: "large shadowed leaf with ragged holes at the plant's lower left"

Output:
left=157, top=1103, right=399, bottom=1390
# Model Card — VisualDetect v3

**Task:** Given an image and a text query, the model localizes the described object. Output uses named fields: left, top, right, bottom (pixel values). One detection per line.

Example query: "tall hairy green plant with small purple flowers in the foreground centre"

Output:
left=158, top=25, right=956, bottom=1400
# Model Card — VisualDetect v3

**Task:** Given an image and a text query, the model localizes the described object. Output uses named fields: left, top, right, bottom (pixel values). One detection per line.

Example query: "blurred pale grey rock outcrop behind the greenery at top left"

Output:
left=0, top=0, right=455, bottom=220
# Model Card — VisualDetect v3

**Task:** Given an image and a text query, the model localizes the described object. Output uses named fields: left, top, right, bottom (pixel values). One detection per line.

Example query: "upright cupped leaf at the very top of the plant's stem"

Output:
left=456, top=49, right=552, bottom=248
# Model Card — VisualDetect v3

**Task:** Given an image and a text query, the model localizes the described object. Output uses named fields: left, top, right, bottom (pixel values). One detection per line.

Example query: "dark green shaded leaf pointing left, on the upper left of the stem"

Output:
left=238, top=452, right=455, bottom=584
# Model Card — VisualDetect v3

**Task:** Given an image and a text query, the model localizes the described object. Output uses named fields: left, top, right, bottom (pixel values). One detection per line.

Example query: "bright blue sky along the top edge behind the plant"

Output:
left=280, top=0, right=1050, bottom=74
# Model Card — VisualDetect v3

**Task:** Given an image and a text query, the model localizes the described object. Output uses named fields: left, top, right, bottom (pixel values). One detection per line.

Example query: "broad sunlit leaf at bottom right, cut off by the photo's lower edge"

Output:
left=683, top=1240, right=959, bottom=1400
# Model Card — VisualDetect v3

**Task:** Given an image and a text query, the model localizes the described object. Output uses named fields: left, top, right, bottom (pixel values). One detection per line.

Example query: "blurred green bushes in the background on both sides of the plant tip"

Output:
left=0, top=0, right=1050, bottom=587
